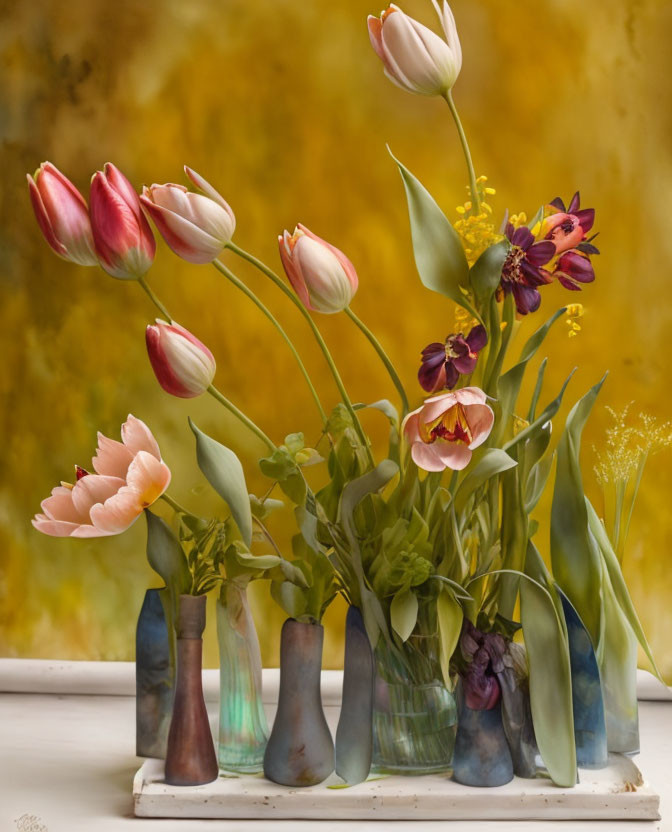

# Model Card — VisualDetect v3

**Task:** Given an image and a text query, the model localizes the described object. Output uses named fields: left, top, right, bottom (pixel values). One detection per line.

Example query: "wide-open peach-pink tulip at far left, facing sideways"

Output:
left=33, top=415, right=170, bottom=537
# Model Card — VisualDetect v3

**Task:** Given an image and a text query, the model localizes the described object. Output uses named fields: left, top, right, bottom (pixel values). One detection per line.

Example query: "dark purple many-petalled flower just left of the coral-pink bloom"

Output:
left=500, top=222, right=555, bottom=315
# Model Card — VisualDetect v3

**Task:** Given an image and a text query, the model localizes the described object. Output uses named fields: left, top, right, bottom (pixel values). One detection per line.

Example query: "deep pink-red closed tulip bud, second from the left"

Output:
left=91, top=162, right=156, bottom=280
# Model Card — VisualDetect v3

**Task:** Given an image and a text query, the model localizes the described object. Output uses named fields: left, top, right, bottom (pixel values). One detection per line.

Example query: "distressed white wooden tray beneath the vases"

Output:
left=133, top=754, right=660, bottom=821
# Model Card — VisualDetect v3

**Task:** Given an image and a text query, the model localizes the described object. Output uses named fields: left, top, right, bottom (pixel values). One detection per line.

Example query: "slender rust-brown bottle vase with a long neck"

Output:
left=165, top=595, right=219, bottom=786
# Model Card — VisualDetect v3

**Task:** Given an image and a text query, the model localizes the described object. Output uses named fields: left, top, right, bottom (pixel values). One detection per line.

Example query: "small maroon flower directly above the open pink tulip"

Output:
left=418, top=324, right=488, bottom=393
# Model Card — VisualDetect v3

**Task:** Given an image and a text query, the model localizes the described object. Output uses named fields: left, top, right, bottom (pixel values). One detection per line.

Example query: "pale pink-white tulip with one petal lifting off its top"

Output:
left=140, top=167, right=236, bottom=263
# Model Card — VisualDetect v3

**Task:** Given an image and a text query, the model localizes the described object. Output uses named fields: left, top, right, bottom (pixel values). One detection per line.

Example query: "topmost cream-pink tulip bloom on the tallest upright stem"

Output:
left=367, top=0, right=462, bottom=96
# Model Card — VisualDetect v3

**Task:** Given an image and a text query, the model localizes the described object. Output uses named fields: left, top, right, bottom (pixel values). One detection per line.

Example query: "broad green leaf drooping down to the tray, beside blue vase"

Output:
left=520, top=560, right=576, bottom=788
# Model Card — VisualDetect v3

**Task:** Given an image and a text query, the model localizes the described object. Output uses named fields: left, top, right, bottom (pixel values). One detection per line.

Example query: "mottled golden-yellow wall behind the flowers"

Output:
left=0, top=0, right=672, bottom=678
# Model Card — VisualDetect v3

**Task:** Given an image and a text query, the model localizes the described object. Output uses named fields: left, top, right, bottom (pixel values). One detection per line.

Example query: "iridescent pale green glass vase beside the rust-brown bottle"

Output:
left=217, top=581, right=268, bottom=773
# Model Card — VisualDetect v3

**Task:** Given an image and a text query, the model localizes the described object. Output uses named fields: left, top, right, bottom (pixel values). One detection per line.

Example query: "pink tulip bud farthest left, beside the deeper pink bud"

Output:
left=26, top=162, right=98, bottom=266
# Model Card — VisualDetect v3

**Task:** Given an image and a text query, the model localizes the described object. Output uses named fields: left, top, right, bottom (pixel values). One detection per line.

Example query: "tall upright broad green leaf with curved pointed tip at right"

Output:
left=551, top=378, right=604, bottom=648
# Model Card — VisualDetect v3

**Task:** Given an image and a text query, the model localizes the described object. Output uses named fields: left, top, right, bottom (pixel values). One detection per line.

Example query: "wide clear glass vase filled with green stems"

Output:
left=372, top=604, right=457, bottom=775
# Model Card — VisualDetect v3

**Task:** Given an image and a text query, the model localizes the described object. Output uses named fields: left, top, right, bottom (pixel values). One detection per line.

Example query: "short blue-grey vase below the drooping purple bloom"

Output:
left=453, top=690, right=513, bottom=787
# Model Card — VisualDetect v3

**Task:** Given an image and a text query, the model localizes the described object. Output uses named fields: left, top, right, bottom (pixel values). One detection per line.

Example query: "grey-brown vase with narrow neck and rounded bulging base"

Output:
left=264, top=618, right=334, bottom=786
